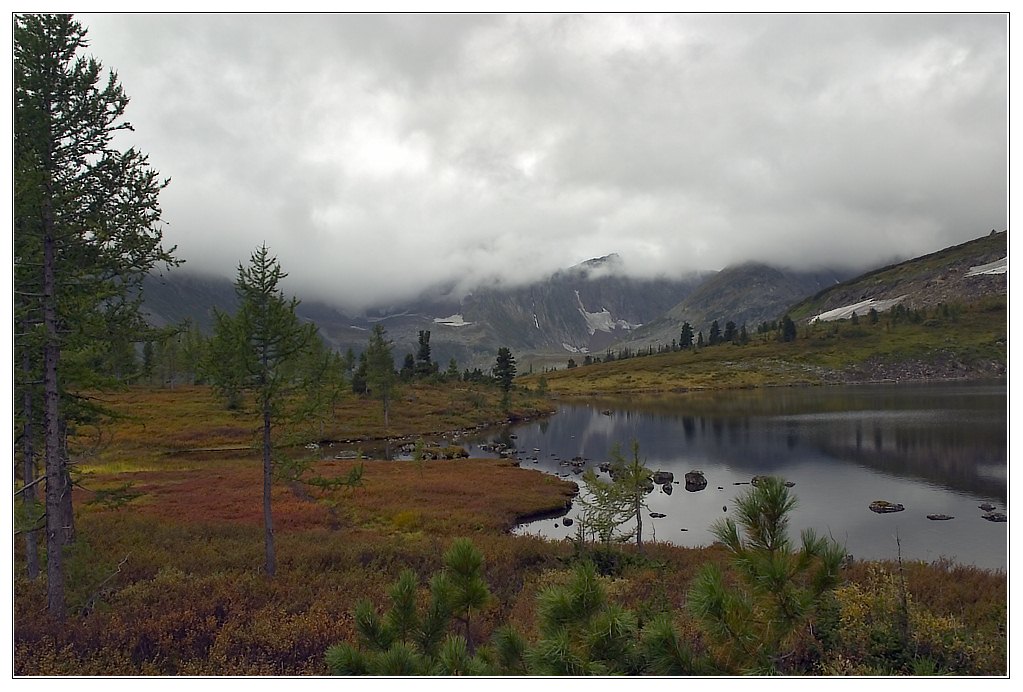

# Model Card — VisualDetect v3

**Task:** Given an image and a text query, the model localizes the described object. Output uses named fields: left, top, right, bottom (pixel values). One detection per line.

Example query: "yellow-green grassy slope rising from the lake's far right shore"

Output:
left=522, top=296, right=1009, bottom=396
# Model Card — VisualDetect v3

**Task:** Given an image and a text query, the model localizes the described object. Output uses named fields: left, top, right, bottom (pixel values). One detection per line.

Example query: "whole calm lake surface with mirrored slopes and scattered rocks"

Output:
left=468, top=384, right=1008, bottom=569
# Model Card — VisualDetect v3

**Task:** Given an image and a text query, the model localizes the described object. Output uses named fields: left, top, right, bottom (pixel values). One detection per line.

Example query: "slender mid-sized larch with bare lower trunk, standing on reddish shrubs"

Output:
left=211, top=245, right=316, bottom=576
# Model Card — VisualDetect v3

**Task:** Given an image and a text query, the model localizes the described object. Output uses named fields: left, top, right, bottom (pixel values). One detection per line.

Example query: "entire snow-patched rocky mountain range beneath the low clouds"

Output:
left=138, top=233, right=1008, bottom=369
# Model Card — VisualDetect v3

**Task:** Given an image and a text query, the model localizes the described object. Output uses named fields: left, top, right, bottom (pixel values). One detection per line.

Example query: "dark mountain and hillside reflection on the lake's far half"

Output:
left=507, top=385, right=1008, bottom=502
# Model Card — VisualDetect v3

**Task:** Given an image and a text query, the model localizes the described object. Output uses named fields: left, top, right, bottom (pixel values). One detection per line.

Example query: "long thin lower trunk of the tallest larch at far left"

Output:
left=43, top=200, right=64, bottom=620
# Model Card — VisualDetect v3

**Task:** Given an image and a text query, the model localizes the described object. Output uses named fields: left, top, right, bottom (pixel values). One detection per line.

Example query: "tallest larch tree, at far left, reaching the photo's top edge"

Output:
left=13, top=14, right=176, bottom=619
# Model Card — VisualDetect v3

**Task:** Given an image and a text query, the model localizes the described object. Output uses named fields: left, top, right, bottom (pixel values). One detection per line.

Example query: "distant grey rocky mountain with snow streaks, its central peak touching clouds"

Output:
left=144, top=255, right=707, bottom=367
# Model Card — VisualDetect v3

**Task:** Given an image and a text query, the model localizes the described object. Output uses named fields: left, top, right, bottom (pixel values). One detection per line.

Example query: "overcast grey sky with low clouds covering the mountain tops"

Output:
left=79, top=14, right=1008, bottom=308
